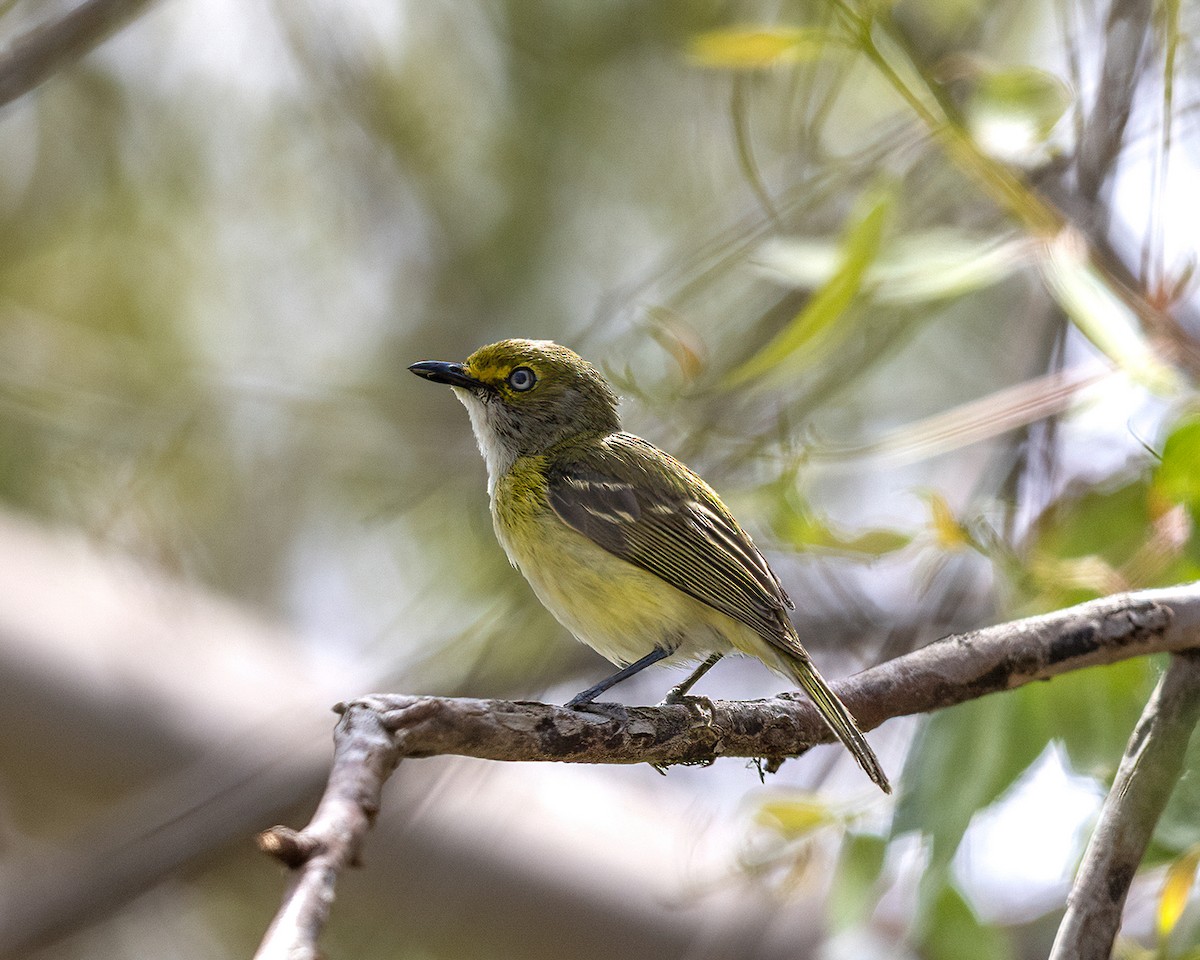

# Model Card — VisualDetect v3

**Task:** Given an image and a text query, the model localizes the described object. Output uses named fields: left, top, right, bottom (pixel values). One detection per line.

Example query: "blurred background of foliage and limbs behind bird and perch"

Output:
left=0, top=0, right=1200, bottom=960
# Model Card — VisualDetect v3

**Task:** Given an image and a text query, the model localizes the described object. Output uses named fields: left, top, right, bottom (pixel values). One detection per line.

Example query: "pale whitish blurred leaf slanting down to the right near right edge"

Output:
left=1040, top=228, right=1180, bottom=394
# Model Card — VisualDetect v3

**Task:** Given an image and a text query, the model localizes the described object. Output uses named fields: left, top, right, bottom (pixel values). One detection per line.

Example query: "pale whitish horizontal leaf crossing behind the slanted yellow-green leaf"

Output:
left=756, top=228, right=1033, bottom=305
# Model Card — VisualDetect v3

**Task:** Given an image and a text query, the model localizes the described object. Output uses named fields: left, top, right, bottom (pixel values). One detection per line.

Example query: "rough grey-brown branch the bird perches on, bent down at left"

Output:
left=257, top=582, right=1200, bottom=960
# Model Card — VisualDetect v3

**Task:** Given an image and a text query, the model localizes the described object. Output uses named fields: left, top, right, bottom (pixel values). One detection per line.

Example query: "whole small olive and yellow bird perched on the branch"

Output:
left=409, top=340, right=890, bottom=792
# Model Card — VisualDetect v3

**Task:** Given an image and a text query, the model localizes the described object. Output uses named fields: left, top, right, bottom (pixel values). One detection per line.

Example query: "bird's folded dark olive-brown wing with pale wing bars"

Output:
left=547, top=433, right=798, bottom=653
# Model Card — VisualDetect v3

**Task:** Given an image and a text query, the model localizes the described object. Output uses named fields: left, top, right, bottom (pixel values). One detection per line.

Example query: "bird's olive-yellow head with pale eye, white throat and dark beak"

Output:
left=409, top=340, right=620, bottom=482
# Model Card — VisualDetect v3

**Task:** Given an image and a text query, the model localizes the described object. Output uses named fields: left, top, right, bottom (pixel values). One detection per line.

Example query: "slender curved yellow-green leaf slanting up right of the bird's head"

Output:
left=727, top=188, right=895, bottom=386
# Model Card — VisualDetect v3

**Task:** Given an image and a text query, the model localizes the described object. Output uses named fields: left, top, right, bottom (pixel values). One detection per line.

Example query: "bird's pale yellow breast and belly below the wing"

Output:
left=492, top=457, right=748, bottom=664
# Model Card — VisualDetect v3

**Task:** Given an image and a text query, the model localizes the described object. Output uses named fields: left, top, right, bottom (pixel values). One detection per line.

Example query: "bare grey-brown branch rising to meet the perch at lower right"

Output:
left=1050, top=653, right=1200, bottom=960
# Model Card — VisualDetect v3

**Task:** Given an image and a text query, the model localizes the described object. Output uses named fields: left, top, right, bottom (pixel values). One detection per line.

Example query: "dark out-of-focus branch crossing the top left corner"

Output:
left=0, top=0, right=159, bottom=106
